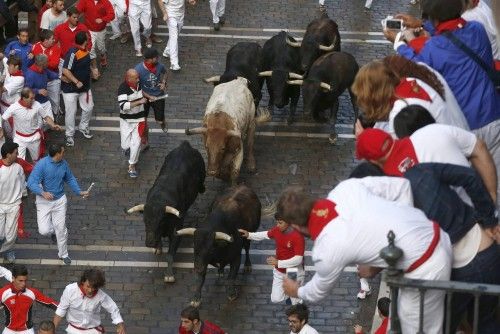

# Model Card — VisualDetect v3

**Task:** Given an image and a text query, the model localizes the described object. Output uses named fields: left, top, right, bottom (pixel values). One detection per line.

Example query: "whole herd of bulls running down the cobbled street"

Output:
left=127, top=14, right=359, bottom=306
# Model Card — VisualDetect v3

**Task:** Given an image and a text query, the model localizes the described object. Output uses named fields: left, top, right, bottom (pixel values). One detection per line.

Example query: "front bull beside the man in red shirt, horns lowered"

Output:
left=178, top=186, right=261, bottom=306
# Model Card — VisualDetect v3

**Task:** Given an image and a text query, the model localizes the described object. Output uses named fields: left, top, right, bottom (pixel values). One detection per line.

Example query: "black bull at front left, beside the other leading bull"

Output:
left=127, top=141, right=206, bottom=282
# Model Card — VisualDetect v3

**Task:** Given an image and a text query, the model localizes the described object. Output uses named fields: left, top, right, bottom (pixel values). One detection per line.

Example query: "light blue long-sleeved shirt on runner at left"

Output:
left=28, top=156, right=81, bottom=200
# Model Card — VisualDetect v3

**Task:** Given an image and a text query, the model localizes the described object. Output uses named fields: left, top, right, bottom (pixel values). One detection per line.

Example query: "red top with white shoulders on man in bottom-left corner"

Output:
left=0, top=283, right=58, bottom=331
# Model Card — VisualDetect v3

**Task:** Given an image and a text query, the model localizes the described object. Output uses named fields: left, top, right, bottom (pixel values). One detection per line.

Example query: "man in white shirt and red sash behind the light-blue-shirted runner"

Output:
left=2, top=87, right=61, bottom=162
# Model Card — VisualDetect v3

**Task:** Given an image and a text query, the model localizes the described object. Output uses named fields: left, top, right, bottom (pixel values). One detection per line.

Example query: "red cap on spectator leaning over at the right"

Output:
left=356, top=129, right=394, bottom=160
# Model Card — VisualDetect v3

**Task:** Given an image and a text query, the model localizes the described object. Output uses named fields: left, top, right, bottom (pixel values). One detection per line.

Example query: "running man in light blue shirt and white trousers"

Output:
left=28, top=144, right=89, bottom=265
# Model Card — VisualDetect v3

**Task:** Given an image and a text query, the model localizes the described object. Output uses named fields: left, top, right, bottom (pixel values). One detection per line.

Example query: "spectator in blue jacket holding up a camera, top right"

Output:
left=384, top=0, right=500, bottom=209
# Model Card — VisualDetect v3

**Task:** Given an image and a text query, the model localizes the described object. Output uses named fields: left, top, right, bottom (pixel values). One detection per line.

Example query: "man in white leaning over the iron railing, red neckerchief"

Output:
left=277, top=184, right=452, bottom=333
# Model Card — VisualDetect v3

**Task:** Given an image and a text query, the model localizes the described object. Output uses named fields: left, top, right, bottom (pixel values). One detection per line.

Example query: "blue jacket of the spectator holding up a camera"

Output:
left=397, top=21, right=500, bottom=130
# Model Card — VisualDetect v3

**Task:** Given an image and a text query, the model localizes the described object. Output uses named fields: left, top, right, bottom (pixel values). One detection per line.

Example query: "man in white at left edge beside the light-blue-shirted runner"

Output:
left=0, top=142, right=33, bottom=263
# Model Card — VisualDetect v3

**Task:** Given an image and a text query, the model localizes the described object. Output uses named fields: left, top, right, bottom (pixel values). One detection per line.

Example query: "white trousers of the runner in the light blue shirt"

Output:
left=36, top=195, right=68, bottom=258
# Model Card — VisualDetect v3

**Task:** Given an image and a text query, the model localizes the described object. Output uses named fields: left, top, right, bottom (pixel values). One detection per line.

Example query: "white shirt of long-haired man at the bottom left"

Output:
left=56, top=283, right=123, bottom=329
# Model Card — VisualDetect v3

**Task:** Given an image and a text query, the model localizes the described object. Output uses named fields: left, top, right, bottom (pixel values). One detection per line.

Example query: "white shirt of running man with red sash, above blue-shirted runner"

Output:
left=2, top=101, right=52, bottom=138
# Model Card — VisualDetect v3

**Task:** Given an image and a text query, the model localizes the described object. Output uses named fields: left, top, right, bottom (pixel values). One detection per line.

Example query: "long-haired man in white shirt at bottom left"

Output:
left=54, top=269, right=126, bottom=334
